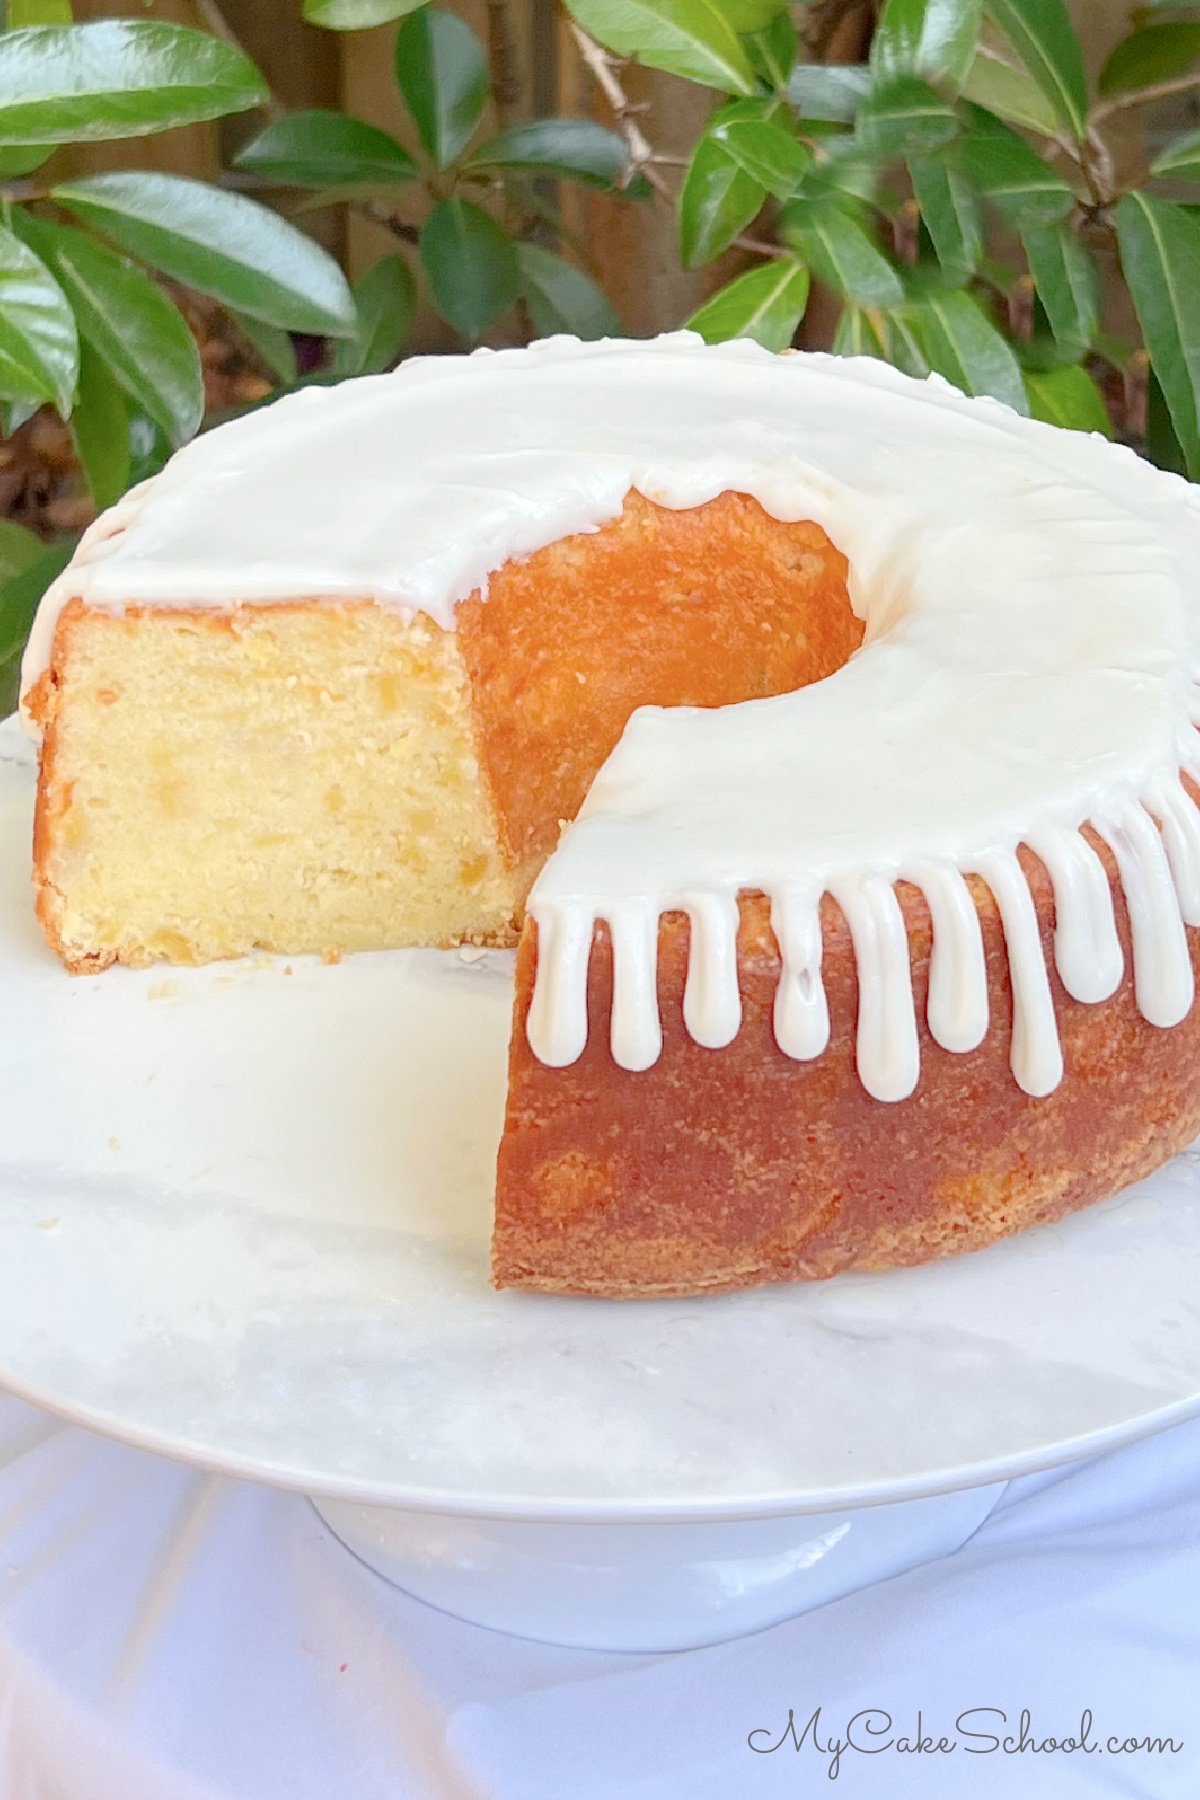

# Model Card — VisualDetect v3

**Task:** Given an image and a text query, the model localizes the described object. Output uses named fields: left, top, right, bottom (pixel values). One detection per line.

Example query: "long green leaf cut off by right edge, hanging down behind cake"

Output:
left=1112, top=191, right=1200, bottom=481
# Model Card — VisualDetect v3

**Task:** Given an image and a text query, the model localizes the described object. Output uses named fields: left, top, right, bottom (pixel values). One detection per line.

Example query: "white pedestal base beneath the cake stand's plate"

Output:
left=313, top=1481, right=1007, bottom=1652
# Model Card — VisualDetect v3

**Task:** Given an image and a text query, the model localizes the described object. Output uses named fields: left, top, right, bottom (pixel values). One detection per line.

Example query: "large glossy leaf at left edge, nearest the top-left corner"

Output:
left=0, top=18, right=266, bottom=144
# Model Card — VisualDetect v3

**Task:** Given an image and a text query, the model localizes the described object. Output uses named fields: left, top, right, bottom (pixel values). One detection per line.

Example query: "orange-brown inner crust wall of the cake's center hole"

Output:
left=459, top=491, right=864, bottom=882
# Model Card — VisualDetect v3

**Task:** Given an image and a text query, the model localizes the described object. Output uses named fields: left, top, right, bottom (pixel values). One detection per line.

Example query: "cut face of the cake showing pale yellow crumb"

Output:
left=31, top=603, right=518, bottom=965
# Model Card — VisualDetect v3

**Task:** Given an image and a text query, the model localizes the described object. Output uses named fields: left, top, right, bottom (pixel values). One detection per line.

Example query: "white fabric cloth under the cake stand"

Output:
left=0, top=1399, right=1200, bottom=1800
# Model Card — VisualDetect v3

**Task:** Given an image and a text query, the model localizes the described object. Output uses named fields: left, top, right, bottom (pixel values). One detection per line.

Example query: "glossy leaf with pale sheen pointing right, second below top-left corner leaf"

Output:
left=53, top=171, right=354, bottom=337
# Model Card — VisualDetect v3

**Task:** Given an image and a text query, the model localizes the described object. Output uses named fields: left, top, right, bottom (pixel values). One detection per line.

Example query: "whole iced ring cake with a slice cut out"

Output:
left=25, top=333, right=1200, bottom=1296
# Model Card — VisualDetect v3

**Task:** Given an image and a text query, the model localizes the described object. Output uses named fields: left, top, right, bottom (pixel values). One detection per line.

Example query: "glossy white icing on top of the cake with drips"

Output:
left=25, top=333, right=1200, bottom=1100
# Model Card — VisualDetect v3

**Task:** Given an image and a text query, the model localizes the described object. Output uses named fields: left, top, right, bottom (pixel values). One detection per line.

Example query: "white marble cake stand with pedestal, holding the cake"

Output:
left=0, top=722, right=1200, bottom=1647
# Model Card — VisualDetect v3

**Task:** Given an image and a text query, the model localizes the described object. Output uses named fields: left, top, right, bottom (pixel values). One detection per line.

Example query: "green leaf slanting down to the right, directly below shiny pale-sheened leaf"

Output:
left=22, top=216, right=203, bottom=445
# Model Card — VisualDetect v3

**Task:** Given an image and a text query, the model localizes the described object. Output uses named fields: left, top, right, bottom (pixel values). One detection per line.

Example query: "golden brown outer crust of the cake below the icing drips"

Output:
left=493, top=833, right=1200, bottom=1296
